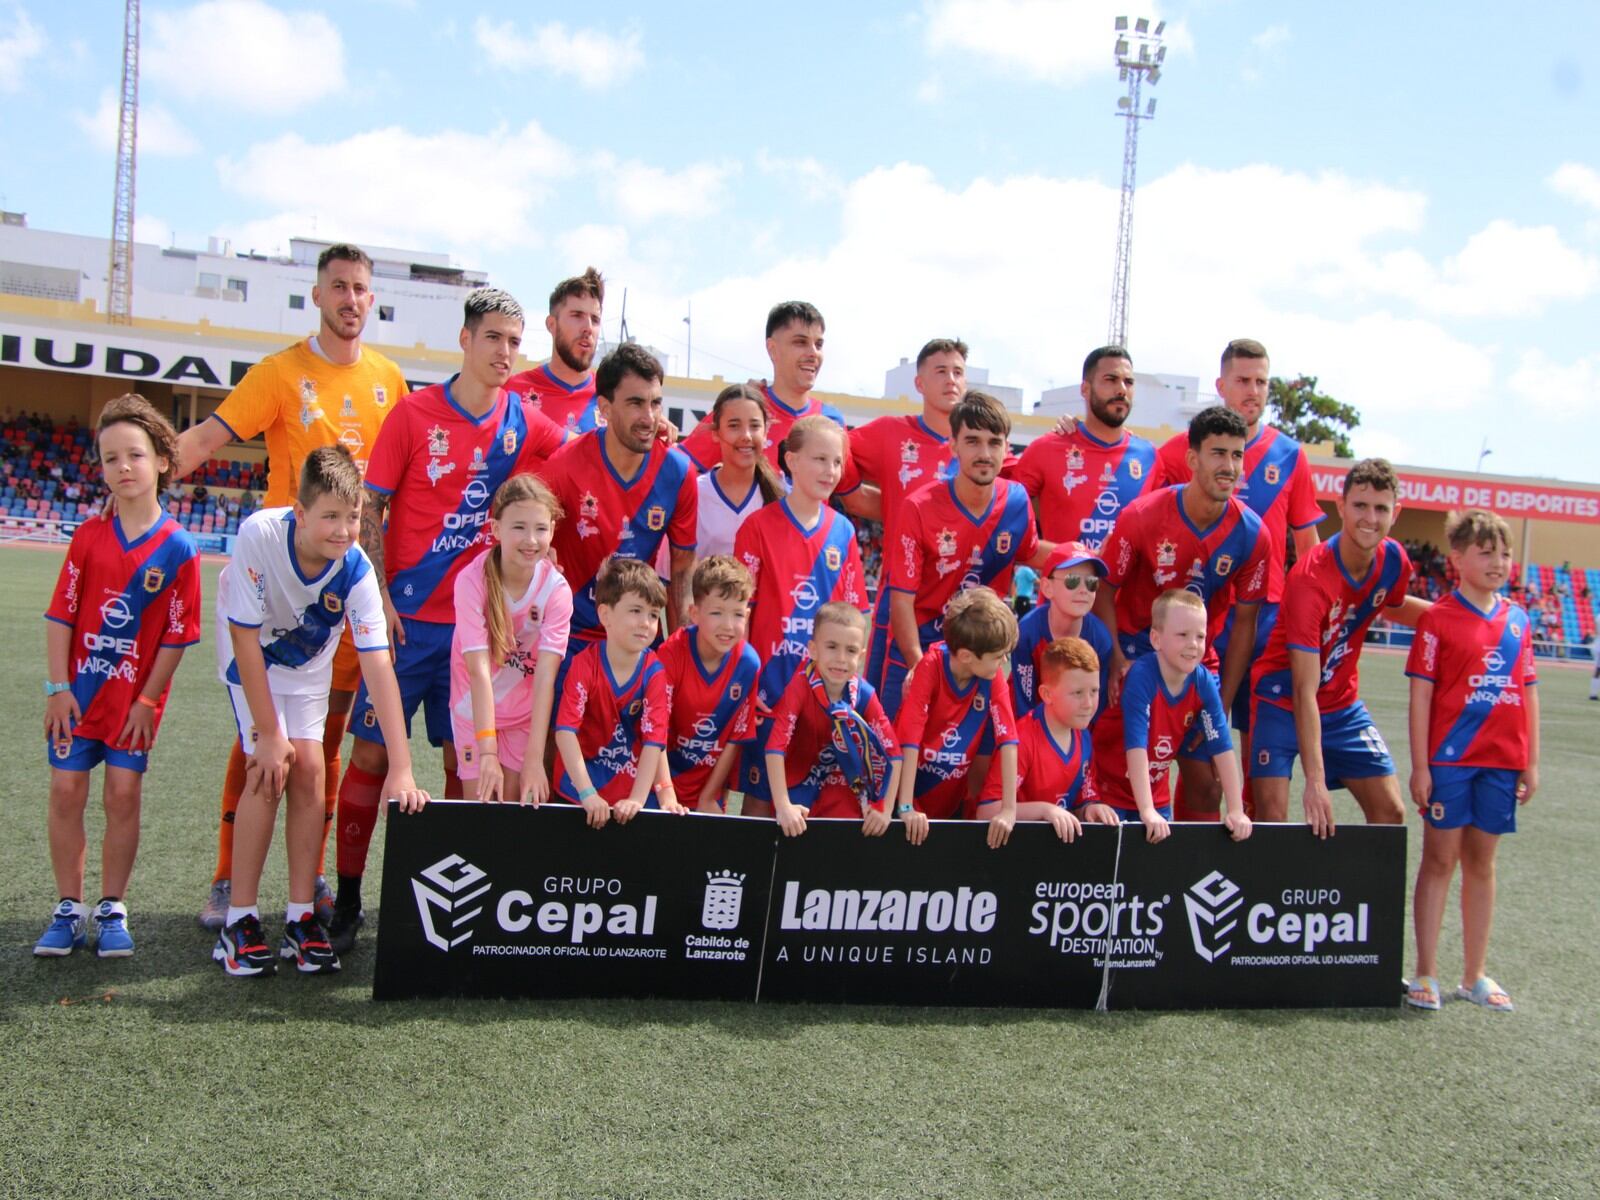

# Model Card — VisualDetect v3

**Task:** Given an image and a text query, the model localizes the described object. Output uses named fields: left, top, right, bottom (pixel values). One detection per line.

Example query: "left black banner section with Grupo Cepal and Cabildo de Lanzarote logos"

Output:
left=373, top=800, right=778, bottom=1000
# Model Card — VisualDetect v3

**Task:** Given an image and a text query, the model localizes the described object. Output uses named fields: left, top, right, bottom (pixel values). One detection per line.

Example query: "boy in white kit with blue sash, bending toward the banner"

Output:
left=211, top=445, right=429, bottom=976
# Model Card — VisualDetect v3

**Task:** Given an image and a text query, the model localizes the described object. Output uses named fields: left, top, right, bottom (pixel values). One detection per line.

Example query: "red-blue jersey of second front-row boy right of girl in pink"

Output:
left=656, top=626, right=762, bottom=806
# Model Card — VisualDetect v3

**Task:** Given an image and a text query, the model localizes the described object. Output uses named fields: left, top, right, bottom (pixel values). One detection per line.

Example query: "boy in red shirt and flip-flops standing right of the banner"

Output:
left=1406, top=509, right=1539, bottom=1013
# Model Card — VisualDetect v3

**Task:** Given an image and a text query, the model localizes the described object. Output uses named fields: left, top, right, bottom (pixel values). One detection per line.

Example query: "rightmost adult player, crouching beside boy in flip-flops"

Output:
left=1250, top=458, right=1429, bottom=837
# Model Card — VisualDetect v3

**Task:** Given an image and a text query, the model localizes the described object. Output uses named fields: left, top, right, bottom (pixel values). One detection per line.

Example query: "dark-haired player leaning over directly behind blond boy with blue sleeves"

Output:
left=1094, top=405, right=1269, bottom=821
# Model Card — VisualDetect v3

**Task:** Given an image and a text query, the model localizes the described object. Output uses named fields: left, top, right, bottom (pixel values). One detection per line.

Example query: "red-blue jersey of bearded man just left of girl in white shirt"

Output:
left=541, top=429, right=699, bottom=653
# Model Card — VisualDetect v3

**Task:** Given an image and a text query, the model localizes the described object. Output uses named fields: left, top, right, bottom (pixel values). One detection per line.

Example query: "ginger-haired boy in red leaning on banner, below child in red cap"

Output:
left=978, top=637, right=1117, bottom=842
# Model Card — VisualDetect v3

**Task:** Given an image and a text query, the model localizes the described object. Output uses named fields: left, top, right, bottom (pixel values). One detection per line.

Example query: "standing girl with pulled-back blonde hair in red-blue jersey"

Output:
left=733, top=416, right=867, bottom=816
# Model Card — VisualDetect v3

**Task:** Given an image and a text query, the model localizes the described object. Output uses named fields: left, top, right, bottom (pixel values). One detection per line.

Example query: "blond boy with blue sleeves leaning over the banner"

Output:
left=1118, top=587, right=1250, bottom=842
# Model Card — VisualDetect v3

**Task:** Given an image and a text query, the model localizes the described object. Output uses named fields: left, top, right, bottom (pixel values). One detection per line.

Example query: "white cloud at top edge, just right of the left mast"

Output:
left=142, top=0, right=346, bottom=112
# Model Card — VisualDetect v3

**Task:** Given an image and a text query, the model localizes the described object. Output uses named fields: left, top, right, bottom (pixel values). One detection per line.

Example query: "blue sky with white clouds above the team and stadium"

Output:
left=0, top=0, right=1600, bottom=480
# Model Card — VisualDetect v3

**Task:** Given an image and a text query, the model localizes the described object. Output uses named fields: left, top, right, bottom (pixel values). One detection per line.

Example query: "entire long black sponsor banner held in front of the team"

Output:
left=373, top=802, right=1406, bottom=1008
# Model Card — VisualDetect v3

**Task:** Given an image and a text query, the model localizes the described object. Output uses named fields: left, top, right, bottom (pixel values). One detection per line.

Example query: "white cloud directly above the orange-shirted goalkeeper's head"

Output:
left=218, top=122, right=574, bottom=251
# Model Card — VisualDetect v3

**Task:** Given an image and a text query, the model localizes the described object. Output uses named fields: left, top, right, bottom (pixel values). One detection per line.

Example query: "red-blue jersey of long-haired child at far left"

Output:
left=45, top=512, right=200, bottom=746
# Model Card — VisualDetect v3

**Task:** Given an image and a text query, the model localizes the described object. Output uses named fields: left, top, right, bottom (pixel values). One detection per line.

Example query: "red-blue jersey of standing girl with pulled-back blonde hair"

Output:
left=733, top=498, right=867, bottom=712
